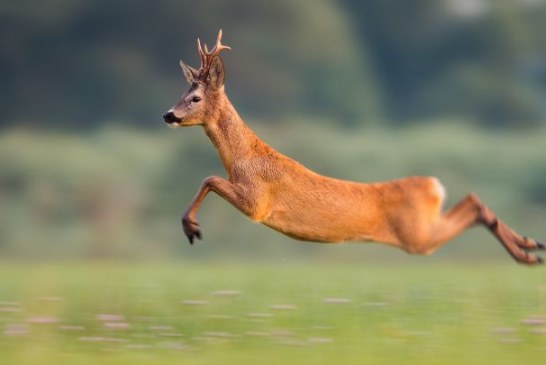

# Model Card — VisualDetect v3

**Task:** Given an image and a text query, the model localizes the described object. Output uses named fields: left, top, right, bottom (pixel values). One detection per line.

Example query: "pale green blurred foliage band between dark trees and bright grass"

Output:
left=0, top=120, right=546, bottom=260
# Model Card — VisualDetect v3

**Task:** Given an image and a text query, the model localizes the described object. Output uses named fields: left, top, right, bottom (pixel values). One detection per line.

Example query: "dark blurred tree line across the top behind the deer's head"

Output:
left=0, top=0, right=546, bottom=129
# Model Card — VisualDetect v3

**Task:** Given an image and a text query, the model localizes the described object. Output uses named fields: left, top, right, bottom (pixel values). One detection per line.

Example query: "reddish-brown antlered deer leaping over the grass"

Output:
left=163, top=30, right=545, bottom=265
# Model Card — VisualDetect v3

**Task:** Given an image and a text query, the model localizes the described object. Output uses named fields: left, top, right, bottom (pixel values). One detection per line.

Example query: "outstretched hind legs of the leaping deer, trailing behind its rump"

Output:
left=416, top=194, right=545, bottom=265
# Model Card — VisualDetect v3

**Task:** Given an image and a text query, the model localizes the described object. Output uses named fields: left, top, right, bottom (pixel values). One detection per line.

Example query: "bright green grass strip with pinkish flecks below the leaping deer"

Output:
left=0, top=260, right=546, bottom=365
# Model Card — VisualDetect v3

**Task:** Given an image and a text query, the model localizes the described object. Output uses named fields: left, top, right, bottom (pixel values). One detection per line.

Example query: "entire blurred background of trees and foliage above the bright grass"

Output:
left=0, top=0, right=546, bottom=262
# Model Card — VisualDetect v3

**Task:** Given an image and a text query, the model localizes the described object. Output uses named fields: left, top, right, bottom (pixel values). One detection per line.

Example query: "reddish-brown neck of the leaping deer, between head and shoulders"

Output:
left=204, top=98, right=266, bottom=177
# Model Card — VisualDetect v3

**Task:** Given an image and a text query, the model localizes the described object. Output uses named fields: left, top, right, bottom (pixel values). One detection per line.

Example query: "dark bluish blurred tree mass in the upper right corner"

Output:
left=345, top=0, right=546, bottom=128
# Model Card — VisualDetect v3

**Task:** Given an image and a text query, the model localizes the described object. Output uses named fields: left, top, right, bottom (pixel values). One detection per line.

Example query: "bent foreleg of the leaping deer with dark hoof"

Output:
left=182, top=176, right=242, bottom=244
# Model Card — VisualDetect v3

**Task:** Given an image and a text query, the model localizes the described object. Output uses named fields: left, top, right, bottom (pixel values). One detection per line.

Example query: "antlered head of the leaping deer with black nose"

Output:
left=163, top=29, right=231, bottom=127
